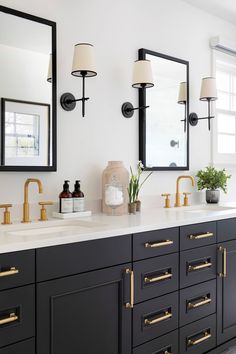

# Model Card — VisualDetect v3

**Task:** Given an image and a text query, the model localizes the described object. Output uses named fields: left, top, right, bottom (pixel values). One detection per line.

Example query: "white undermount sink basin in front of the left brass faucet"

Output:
left=7, top=220, right=105, bottom=236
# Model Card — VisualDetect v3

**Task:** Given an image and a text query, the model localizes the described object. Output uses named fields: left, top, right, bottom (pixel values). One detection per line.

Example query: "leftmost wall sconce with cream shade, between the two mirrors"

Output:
left=60, top=43, right=97, bottom=117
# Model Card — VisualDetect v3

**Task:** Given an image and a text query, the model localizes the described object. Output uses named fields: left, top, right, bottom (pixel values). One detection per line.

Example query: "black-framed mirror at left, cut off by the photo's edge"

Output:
left=0, top=6, right=57, bottom=171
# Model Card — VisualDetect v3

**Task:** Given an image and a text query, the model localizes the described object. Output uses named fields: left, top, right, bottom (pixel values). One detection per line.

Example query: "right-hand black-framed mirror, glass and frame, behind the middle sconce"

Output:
left=138, top=48, right=189, bottom=171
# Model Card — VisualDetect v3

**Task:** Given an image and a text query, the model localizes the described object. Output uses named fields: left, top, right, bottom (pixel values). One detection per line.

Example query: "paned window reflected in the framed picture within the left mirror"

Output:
left=5, top=112, right=39, bottom=158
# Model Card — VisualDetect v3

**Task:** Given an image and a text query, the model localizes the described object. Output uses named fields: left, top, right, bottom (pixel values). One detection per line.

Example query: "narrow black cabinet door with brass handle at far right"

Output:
left=217, top=241, right=236, bottom=345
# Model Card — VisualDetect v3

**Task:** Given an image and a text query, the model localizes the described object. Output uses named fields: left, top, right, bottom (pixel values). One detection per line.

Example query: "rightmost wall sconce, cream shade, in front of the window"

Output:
left=189, top=77, right=217, bottom=130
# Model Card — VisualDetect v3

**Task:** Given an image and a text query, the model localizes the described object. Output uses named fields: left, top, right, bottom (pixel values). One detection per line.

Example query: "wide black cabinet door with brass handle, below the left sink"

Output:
left=37, top=264, right=132, bottom=354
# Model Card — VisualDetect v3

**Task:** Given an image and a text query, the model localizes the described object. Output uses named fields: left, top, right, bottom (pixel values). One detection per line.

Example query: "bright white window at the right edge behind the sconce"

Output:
left=213, top=51, right=236, bottom=164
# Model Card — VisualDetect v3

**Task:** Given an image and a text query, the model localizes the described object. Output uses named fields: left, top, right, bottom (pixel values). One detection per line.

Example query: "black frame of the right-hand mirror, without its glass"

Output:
left=138, top=48, right=189, bottom=171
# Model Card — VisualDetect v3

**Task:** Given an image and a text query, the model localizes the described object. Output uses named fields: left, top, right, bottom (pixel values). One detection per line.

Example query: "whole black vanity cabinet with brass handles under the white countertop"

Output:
left=3, top=218, right=236, bottom=354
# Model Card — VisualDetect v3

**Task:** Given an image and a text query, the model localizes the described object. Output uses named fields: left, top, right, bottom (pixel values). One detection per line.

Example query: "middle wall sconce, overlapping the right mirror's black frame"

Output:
left=121, top=60, right=154, bottom=118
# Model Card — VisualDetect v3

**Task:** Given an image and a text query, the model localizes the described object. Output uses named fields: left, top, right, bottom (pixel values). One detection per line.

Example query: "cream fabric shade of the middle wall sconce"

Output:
left=132, top=60, right=154, bottom=88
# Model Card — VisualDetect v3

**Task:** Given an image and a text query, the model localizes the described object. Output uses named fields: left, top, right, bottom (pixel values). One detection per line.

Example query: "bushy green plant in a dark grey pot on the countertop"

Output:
left=196, top=166, right=231, bottom=203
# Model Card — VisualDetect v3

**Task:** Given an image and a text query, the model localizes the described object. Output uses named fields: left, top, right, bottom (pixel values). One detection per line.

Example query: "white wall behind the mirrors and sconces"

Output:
left=0, top=0, right=236, bottom=218
